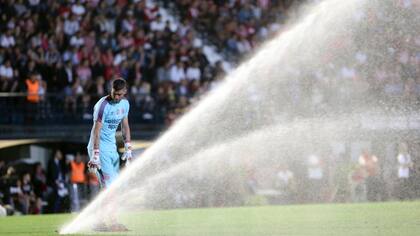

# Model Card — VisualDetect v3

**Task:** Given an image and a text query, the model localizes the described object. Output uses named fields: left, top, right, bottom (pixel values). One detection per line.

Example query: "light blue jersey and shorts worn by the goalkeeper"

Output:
left=87, top=96, right=130, bottom=186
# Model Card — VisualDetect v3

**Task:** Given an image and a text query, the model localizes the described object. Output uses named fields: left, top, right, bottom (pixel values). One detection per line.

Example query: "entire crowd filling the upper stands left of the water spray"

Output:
left=0, top=0, right=322, bottom=124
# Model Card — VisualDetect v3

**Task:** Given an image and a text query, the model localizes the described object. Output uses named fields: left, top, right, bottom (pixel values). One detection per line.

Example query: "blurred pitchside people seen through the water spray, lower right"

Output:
left=246, top=142, right=420, bottom=204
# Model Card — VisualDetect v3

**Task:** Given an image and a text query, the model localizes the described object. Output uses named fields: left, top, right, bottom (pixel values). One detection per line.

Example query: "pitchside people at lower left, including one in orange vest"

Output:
left=0, top=150, right=99, bottom=215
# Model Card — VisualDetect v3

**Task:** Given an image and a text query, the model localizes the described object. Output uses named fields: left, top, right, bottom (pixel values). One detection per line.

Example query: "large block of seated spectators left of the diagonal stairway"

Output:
left=0, top=0, right=216, bottom=125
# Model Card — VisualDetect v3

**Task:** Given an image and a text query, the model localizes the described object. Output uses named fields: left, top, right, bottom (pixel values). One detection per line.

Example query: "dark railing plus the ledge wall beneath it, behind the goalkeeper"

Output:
left=0, top=93, right=165, bottom=140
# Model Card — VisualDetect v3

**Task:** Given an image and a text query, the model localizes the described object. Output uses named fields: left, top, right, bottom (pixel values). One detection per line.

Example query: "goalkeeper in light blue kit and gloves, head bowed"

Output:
left=87, top=78, right=132, bottom=231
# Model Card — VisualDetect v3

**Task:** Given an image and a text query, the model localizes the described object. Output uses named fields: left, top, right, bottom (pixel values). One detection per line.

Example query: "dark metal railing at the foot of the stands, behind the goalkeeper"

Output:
left=0, top=93, right=164, bottom=125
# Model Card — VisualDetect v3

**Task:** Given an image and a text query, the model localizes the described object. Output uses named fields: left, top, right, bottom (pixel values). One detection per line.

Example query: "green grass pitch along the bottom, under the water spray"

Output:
left=0, top=202, right=420, bottom=236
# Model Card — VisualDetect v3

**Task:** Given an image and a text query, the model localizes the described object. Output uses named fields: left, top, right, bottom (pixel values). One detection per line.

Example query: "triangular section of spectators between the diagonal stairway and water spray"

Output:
left=164, top=0, right=296, bottom=62
